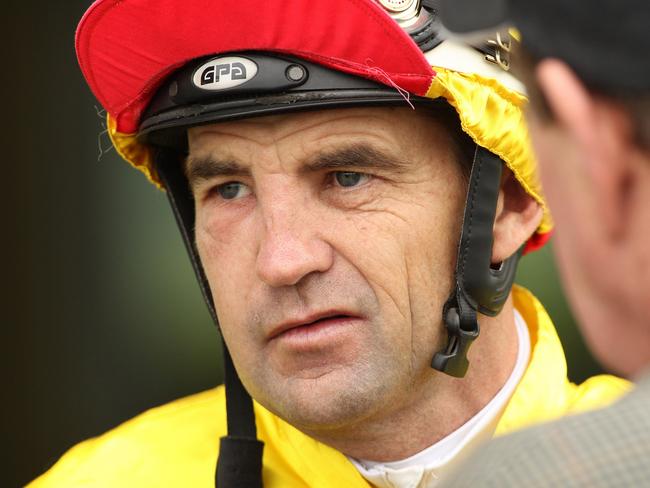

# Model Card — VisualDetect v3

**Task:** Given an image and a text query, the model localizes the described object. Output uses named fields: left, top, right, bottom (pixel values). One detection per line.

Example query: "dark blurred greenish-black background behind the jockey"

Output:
left=0, top=0, right=599, bottom=487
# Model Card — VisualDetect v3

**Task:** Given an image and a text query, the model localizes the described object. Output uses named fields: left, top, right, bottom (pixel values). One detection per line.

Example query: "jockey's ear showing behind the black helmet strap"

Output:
left=492, top=168, right=542, bottom=264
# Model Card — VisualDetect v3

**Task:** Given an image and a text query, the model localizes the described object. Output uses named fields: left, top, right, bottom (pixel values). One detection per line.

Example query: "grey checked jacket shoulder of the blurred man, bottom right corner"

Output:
left=442, top=375, right=650, bottom=488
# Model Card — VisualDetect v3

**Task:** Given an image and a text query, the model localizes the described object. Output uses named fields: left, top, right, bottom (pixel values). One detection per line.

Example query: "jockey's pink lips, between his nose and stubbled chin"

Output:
left=272, top=317, right=362, bottom=349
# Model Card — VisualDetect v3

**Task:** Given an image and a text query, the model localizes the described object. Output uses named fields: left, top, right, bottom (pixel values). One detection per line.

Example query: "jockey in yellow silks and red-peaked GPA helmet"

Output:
left=34, top=0, right=626, bottom=487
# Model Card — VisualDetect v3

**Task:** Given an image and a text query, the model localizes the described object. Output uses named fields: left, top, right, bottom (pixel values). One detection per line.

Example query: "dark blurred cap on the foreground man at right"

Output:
left=440, top=0, right=650, bottom=93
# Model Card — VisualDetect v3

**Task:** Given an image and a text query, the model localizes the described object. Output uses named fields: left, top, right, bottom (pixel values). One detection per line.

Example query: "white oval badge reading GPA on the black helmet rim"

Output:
left=192, top=56, right=257, bottom=90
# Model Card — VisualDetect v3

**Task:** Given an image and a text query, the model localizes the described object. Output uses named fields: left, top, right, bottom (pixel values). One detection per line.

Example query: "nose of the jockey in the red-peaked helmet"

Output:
left=256, top=192, right=334, bottom=287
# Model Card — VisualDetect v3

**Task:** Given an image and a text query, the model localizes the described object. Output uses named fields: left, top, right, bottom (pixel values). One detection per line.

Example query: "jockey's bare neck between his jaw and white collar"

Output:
left=305, top=298, right=518, bottom=462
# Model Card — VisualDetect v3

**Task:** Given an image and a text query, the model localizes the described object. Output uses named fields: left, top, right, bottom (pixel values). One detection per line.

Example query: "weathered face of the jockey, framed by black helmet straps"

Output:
left=187, top=108, right=466, bottom=429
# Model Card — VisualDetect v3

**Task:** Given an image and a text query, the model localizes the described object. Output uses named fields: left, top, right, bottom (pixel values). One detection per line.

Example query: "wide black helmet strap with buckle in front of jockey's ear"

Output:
left=431, top=145, right=523, bottom=378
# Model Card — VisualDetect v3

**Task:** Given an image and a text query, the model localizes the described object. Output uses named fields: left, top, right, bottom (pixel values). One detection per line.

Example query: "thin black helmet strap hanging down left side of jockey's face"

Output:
left=155, top=149, right=264, bottom=488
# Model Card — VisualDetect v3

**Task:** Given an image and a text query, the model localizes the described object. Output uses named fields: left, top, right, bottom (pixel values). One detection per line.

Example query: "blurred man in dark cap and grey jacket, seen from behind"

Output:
left=436, top=0, right=650, bottom=487
